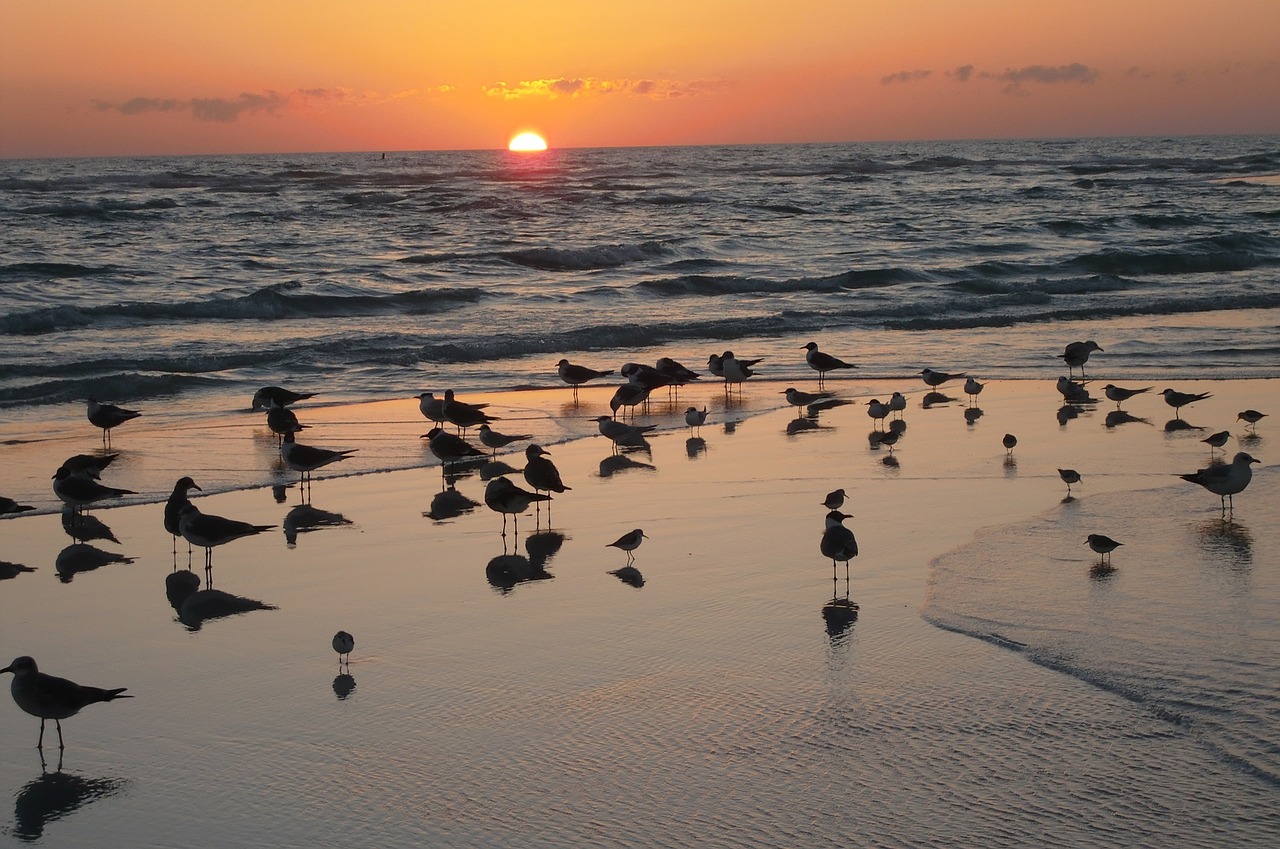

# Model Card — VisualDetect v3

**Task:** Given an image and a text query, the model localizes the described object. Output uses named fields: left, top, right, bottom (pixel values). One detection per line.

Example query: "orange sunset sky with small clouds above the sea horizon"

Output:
left=0, top=0, right=1280, bottom=158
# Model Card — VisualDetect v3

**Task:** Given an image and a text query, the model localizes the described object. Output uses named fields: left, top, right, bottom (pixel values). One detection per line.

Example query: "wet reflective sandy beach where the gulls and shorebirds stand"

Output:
left=0, top=379, right=1280, bottom=846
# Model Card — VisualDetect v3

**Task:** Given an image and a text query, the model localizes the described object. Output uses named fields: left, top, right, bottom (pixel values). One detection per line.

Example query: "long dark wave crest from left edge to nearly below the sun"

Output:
left=0, top=283, right=484, bottom=336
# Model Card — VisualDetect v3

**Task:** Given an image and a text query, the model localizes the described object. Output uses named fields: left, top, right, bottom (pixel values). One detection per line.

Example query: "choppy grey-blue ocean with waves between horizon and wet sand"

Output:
left=0, top=137, right=1280, bottom=421
